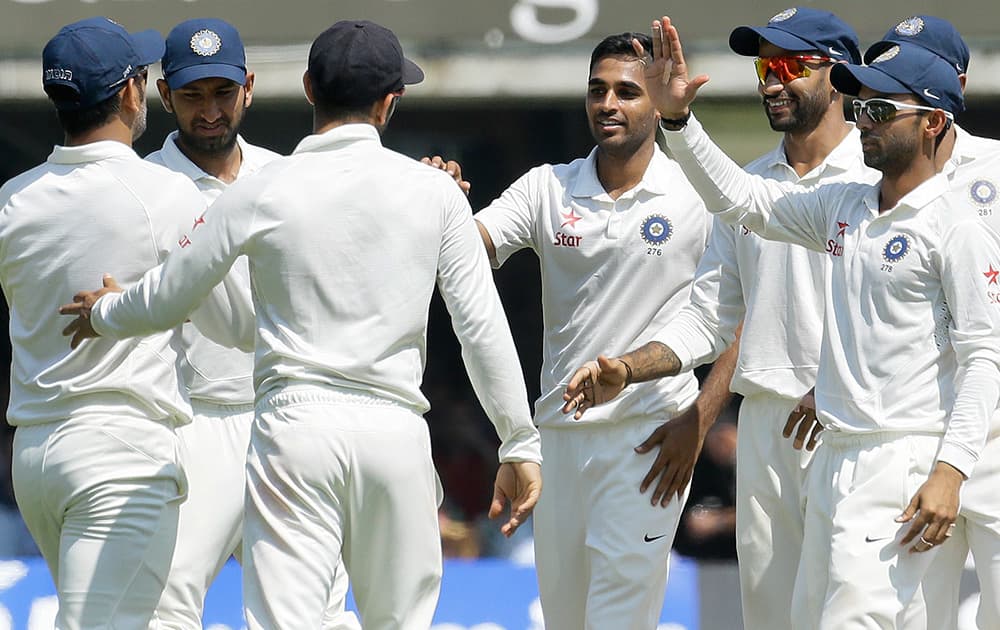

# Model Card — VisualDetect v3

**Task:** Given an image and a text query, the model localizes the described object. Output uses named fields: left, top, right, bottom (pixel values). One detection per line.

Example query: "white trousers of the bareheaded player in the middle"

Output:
left=536, top=421, right=688, bottom=630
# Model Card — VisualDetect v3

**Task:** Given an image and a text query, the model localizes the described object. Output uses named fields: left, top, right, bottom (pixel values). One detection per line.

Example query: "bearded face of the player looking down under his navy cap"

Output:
left=157, top=74, right=253, bottom=155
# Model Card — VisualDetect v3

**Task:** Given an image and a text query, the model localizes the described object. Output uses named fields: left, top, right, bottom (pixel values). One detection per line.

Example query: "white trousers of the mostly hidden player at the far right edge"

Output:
left=922, top=437, right=1000, bottom=630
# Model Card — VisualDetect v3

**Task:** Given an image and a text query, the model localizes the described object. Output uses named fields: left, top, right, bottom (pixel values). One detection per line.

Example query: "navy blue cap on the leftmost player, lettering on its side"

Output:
left=42, top=17, right=163, bottom=110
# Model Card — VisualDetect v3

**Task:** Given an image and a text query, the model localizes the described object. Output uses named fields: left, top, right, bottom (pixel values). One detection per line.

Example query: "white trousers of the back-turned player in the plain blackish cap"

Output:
left=243, top=387, right=442, bottom=630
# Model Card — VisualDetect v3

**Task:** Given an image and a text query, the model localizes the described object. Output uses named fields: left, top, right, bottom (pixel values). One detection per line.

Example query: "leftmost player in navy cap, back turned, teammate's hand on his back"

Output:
left=0, top=17, right=205, bottom=630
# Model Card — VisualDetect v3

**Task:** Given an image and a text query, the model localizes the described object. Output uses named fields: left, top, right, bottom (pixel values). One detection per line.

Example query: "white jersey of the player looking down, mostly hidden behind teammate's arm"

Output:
left=146, top=131, right=281, bottom=404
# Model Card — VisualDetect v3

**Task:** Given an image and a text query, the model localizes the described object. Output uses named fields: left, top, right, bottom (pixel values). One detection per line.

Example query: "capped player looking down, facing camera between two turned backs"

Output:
left=146, top=18, right=360, bottom=629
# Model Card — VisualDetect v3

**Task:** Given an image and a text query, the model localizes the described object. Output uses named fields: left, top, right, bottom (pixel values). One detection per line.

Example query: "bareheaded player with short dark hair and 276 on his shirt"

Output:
left=476, top=33, right=735, bottom=630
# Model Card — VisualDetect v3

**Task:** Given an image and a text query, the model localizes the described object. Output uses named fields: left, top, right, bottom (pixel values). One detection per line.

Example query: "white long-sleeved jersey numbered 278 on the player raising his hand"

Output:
left=665, top=119, right=1000, bottom=475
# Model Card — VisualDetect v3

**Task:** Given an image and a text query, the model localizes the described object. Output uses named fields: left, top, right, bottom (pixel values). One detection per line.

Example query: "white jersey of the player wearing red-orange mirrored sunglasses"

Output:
left=654, top=128, right=881, bottom=398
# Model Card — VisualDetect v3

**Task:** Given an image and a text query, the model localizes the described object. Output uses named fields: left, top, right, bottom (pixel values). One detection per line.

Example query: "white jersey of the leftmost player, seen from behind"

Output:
left=0, top=141, right=205, bottom=425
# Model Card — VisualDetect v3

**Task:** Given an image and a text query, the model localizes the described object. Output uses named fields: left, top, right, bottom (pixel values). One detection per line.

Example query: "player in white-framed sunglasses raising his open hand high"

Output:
left=616, top=17, right=1000, bottom=630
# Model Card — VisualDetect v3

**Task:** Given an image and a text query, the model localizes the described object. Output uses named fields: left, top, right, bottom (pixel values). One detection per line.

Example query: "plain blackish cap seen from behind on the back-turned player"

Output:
left=308, top=20, right=424, bottom=105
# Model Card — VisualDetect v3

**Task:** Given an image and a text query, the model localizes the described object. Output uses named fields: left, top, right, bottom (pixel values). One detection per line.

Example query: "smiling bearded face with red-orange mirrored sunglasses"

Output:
left=757, top=42, right=833, bottom=133
